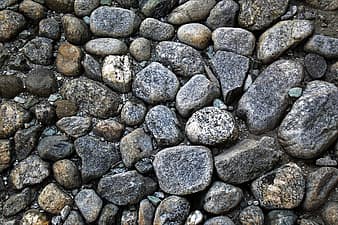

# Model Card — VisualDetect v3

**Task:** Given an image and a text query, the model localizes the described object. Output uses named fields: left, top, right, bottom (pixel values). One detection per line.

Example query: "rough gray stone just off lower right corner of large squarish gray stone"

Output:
left=203, top=181, right=243, bottom=214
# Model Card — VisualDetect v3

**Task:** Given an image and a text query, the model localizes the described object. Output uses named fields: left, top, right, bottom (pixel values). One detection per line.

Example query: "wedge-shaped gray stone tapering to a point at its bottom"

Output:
left=211, top=51, right=250, bottom=104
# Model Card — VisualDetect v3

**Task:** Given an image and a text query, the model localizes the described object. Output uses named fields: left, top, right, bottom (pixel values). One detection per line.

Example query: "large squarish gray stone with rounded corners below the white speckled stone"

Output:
left=153, top=145, right=213, bottom=195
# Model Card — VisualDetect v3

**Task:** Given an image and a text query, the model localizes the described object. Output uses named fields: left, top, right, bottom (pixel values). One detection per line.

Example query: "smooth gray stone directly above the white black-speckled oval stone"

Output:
left=175, top=74, right=220, bottom=117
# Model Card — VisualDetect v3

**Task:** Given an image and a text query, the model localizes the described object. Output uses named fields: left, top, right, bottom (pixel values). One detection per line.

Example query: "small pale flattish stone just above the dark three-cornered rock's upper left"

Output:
left=56, top=116, right=91, bottom=138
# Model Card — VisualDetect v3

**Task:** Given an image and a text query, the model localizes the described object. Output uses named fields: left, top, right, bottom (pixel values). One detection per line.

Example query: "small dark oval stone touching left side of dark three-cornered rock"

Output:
left=37, top=136, right=74, bottom=161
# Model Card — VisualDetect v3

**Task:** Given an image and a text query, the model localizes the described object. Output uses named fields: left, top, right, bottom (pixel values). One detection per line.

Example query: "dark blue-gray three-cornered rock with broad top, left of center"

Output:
left=74, top=136, right=120, bottom=183
